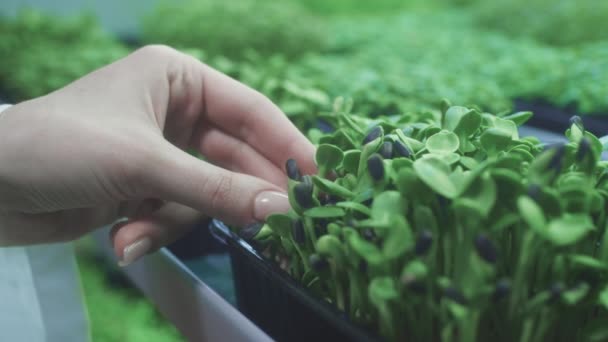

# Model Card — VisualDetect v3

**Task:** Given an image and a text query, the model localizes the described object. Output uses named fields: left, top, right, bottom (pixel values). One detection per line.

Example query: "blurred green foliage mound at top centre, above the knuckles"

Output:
left=143, top=0, right=325, bottom=59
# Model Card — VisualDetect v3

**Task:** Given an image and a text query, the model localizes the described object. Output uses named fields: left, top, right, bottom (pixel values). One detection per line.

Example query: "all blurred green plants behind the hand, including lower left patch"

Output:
left=0, top=0, right=608, bottom=341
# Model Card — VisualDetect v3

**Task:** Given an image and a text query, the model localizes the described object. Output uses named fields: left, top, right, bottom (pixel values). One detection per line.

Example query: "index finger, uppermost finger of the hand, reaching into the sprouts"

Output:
left=195, top=65, right=315, bottom=173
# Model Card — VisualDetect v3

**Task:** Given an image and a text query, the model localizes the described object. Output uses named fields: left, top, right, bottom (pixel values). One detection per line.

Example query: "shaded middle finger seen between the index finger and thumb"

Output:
left=199, top=127, right=287, bottom=189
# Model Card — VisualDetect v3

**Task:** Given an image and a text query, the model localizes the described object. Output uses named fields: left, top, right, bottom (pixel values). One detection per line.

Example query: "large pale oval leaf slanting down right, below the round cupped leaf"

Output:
left=414, top=158, right=458, bottom=198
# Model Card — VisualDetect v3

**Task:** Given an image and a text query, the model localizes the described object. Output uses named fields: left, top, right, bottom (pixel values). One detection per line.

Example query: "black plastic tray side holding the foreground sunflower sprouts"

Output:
left=210, top=220, right=380, bottom=342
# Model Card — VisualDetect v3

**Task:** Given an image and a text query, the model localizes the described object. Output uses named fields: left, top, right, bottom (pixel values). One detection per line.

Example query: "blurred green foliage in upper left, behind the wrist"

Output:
left=0, top=10, right=128, bottom=101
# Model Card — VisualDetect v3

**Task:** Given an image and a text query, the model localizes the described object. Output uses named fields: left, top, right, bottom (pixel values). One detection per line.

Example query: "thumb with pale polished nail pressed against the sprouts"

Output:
left=139, top=142, right=290, bottom=226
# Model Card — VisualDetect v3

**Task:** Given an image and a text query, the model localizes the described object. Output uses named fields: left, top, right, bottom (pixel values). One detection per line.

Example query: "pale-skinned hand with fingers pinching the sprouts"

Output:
left=0, top=46, right=315, bottom=265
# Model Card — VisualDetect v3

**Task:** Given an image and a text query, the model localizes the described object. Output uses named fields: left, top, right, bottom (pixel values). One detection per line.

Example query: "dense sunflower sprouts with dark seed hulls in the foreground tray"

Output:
left=245, top=105, right=608, bottom=341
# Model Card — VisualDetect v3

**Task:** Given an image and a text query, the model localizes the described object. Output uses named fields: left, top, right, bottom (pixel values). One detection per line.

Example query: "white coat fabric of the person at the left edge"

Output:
left=0, top=105, right=90, bottom=342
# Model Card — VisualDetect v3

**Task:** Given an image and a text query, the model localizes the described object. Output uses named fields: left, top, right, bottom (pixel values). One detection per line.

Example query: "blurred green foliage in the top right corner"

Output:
left=474, top=0, right=608, bottom=46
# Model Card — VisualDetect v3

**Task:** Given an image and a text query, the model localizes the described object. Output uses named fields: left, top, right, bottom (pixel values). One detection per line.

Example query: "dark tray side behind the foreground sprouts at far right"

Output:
left=514, top=99, right=608, bottom=137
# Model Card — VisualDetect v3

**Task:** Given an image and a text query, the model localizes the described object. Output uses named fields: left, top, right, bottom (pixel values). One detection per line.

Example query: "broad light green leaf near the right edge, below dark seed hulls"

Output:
left=546, top=214, right=595, bottom=246
